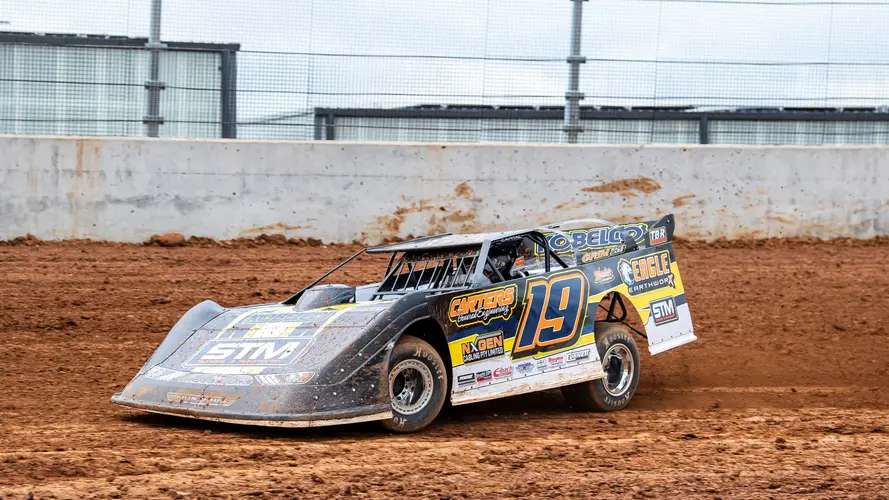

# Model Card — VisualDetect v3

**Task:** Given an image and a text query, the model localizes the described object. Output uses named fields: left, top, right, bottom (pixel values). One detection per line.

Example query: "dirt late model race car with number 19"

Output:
left=112, top=215, right=695, bottom=432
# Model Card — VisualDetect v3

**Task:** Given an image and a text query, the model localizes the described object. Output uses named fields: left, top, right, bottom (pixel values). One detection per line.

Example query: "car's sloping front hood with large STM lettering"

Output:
left=145, top=302, right=392, bottom=386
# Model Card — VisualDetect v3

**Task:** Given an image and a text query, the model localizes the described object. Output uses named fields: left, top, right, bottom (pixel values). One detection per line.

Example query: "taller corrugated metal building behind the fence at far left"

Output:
left=0, top=32, right=240, bottom=137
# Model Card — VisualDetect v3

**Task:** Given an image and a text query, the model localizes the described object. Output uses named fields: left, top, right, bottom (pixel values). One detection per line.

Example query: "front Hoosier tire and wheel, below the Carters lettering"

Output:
left=381, top=335, right=448, bottom=433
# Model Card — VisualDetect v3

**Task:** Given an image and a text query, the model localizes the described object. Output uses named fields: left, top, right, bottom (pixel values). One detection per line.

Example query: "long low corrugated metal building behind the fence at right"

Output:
left=314, top=105, right=889, bottom=145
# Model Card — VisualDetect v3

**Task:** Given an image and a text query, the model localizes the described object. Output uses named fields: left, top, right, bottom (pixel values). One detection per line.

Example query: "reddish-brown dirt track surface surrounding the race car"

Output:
left=0, top=243, right=889, bottom=498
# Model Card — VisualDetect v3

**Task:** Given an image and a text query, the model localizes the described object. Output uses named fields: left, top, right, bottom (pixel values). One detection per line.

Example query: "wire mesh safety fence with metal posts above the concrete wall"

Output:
left=0, top=0, right=889, bottom=144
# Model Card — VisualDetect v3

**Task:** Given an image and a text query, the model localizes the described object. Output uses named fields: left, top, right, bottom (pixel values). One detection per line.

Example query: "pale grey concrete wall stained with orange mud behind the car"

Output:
left=0, top=137, right=889, bottom=242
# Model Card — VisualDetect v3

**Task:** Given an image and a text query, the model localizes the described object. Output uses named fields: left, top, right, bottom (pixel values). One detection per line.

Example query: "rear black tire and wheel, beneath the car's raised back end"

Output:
left=562, top=322, right=641, bottom=412
